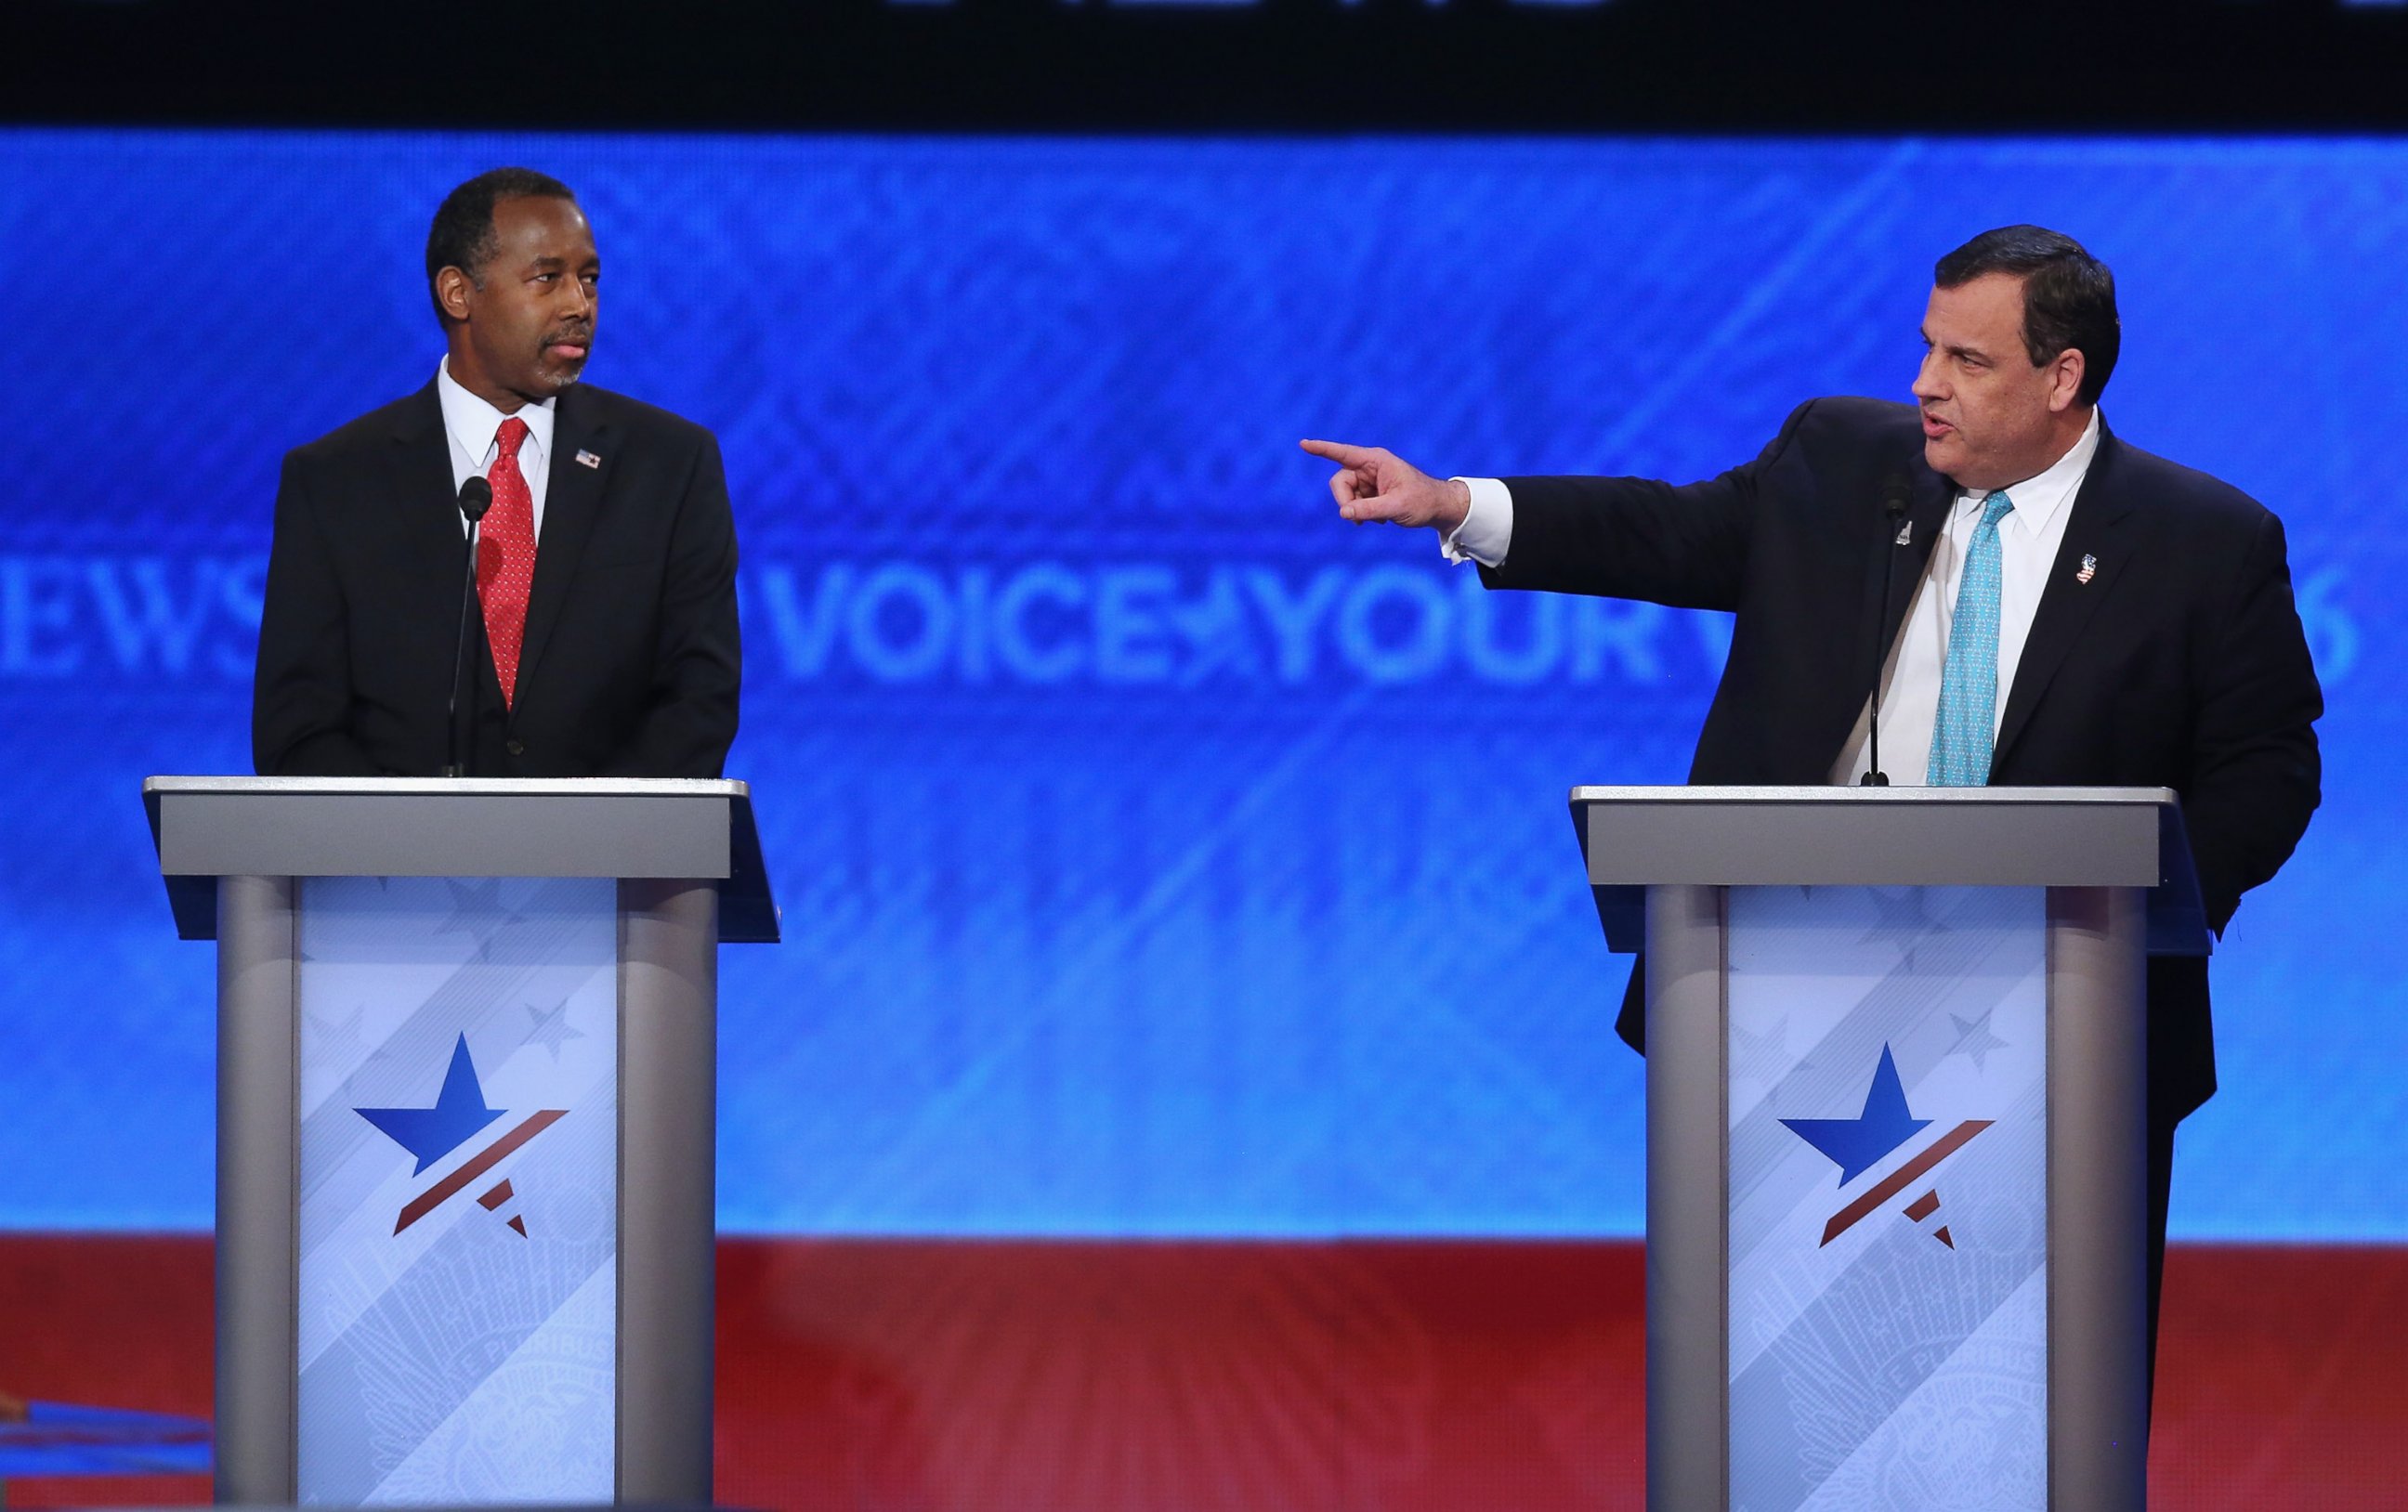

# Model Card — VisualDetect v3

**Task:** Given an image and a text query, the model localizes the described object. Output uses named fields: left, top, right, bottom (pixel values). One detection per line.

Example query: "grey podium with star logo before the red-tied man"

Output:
left=142, top=777, right=778, bottom=1505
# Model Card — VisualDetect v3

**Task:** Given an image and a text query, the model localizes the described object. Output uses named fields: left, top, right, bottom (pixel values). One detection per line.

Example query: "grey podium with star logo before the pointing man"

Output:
left=1573, top=788, right=2208, bottom=1512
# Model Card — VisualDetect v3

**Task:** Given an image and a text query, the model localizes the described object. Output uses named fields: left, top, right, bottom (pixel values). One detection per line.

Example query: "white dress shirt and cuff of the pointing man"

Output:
left=1440, top=410, right=2100, bottom=788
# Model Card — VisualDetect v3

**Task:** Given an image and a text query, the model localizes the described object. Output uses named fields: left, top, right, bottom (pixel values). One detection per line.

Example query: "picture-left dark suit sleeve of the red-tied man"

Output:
left=251, top=455, right=383, bottom=777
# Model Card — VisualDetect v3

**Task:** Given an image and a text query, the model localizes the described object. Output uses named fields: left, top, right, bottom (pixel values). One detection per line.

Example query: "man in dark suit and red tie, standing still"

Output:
left=253, top=168, right=739, bottom=777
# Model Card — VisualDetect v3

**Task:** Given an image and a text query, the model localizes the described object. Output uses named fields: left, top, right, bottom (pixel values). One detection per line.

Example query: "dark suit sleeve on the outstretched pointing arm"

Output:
left=1481, top=402, right=1813, bottom=609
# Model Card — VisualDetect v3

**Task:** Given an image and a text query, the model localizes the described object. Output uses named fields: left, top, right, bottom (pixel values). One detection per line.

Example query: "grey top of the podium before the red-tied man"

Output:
left=142, top=777, right=778, bottom=942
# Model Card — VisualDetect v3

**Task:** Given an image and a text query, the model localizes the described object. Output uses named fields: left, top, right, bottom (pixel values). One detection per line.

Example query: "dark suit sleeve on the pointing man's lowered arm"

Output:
left=2181, top=515, right=2323, bottom=932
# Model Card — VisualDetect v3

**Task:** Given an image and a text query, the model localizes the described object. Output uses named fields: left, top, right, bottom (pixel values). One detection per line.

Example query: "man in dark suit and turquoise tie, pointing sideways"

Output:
left=1305, top=227, right=2323, bottom=1367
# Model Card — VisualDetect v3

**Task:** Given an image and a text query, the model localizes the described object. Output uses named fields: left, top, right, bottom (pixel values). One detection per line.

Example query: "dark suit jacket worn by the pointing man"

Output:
left=1481, top=389, right=2323, bottom=1127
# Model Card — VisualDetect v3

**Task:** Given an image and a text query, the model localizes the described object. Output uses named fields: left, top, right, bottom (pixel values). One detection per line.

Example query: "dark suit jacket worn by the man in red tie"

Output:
left=251, top=383, right=739, bottom=777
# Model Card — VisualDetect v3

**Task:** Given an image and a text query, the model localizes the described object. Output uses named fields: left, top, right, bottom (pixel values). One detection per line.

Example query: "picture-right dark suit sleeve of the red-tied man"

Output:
left=599, top=436, right=741, bottom=777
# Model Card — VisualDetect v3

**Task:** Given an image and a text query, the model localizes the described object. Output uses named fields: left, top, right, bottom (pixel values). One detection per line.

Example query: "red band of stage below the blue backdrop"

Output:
left=0, top=1235, right=2408, bottom=1512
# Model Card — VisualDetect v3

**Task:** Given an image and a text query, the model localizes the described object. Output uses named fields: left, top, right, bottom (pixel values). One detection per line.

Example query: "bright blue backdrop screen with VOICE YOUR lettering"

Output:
left=0, top=133, right=2408, bottom=1237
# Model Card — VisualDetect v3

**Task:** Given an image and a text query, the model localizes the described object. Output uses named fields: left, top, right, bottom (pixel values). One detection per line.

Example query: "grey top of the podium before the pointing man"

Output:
left=1573, top=788, right=2205, bottom=954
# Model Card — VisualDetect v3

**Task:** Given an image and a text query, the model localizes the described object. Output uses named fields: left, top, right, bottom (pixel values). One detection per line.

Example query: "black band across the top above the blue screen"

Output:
left=14, top=0, right=2408, bottom=133
